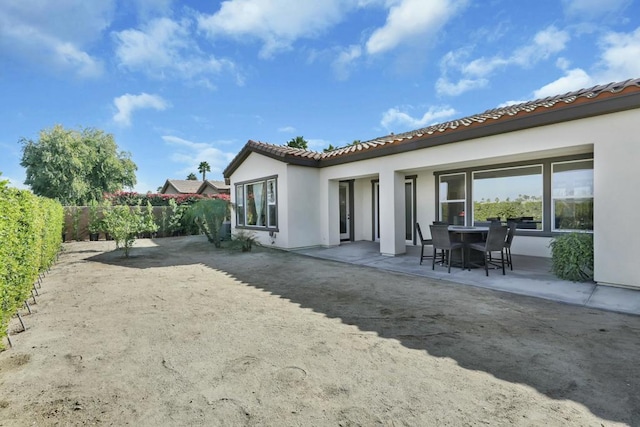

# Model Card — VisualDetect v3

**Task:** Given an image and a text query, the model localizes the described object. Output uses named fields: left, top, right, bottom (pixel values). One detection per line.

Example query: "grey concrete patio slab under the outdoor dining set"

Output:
left=293, top=241, right=640, bottom=315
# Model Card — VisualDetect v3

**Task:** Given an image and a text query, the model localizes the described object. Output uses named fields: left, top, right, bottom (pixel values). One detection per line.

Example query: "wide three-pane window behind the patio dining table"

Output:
left=435, top=153, right=594, bottom=236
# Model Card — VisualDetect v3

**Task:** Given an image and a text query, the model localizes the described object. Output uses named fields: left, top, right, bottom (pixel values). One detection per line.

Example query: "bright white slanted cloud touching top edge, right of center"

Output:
left=366, top=0, right=466, bottom=55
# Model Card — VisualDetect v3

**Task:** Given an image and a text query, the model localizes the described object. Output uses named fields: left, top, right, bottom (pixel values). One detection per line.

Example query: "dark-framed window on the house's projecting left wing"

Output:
left=236, top=178, right=278, bottom=228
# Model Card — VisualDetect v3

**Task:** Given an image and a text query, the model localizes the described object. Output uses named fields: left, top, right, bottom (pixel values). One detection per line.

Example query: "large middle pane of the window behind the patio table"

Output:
left=473, top=165, right=544, bottom=230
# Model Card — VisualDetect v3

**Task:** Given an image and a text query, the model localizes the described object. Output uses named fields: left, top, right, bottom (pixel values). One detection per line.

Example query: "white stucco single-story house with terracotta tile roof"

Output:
left=224, top=79, right=640, bottom=288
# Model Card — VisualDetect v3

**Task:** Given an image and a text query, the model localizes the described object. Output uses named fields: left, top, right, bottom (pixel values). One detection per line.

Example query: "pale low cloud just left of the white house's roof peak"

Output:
left=162, top=135, right=237, bottom=180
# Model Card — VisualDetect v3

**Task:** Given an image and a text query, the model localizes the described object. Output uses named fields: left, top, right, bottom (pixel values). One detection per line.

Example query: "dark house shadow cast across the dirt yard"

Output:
left=88, top=238, right=640, bottom=425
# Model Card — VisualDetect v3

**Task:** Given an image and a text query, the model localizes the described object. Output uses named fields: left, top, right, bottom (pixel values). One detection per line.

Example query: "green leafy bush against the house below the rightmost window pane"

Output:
left=550, top=233, right=593, bottom=282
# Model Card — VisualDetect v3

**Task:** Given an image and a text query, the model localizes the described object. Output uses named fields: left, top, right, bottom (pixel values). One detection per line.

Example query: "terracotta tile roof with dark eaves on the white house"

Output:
left=224, top=79, right=640, bottom=178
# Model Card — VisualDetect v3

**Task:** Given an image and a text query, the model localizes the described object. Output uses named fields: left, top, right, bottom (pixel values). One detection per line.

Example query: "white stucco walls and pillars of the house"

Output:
left=225, top=86, right=640, bottom=287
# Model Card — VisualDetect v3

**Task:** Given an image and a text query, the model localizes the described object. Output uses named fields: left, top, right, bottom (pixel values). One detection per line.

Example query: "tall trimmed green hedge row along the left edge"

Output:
left=0, top=186, right=63, bottom=346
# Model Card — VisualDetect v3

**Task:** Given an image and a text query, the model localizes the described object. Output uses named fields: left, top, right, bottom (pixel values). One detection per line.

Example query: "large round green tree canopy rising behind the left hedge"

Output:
left=20, top=125, right=138, bottom=205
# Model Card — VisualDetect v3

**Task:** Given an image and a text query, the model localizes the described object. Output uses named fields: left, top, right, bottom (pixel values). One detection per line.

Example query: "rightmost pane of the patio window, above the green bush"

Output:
left=551, top=159, right=593, bottom=231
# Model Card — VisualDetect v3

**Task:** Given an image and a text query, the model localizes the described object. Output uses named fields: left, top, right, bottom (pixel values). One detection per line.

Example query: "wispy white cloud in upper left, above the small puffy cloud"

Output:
left=114, top=18, right=243, bottom=84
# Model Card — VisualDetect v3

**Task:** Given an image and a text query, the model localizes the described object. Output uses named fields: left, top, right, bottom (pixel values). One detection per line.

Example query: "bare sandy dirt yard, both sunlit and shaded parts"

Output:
left=0, top=237, right=640, bottom=426
